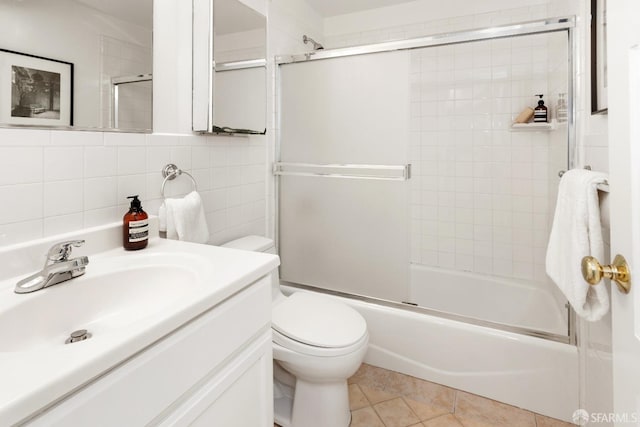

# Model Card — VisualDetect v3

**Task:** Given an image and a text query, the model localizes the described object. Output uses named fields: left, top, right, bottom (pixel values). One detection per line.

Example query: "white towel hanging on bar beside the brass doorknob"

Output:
left=546, top=169, right=609, bottom=322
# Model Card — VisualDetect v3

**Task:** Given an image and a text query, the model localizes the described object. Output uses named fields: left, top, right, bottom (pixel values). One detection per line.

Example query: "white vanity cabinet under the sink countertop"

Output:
left=25, top=275, right=273, bottom=427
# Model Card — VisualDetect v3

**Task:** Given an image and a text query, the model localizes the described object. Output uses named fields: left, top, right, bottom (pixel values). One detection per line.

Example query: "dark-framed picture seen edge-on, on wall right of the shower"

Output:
left=591, top=0, right=609, bottom=114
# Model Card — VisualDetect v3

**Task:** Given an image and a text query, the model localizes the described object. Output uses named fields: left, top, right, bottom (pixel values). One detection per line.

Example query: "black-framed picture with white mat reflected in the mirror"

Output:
left=0, top=49, right=73, bottom=126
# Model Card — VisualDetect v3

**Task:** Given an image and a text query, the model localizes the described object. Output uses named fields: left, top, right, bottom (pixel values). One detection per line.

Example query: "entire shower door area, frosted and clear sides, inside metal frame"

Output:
left=276, top=27, right=573, bottom=341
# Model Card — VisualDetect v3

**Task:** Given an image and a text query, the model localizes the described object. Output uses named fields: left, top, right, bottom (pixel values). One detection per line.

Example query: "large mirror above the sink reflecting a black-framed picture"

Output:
left=0, top=0, right=153, bottom=131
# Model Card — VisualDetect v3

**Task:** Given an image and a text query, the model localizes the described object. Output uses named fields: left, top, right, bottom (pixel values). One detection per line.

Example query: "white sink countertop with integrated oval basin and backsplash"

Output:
left=0, top=221, right=279, bottom=425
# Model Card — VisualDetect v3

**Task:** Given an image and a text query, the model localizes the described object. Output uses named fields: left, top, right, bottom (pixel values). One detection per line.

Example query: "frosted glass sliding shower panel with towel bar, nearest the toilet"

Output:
left=277, top=52, right=410, bottom=301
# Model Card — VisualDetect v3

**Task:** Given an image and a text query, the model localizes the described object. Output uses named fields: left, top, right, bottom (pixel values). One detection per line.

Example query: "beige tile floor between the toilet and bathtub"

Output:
left=274, top=364, right=573, bottom=427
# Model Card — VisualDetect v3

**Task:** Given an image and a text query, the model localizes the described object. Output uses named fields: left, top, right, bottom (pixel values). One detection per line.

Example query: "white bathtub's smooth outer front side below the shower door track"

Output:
left=282, top=283, right=579, bottom=422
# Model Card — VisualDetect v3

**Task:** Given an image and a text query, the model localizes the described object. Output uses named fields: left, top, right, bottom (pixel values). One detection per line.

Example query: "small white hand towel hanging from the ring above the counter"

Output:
left=164, top=191, right=209, bottom=243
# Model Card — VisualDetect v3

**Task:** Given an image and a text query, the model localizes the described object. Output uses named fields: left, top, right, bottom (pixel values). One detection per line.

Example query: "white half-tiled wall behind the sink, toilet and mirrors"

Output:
left=0, top=0, right=322, bottom=245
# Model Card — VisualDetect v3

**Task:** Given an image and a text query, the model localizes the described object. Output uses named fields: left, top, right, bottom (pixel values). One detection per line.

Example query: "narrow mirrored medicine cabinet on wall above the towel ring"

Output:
left=193, top=0, right=267, bottom=135
